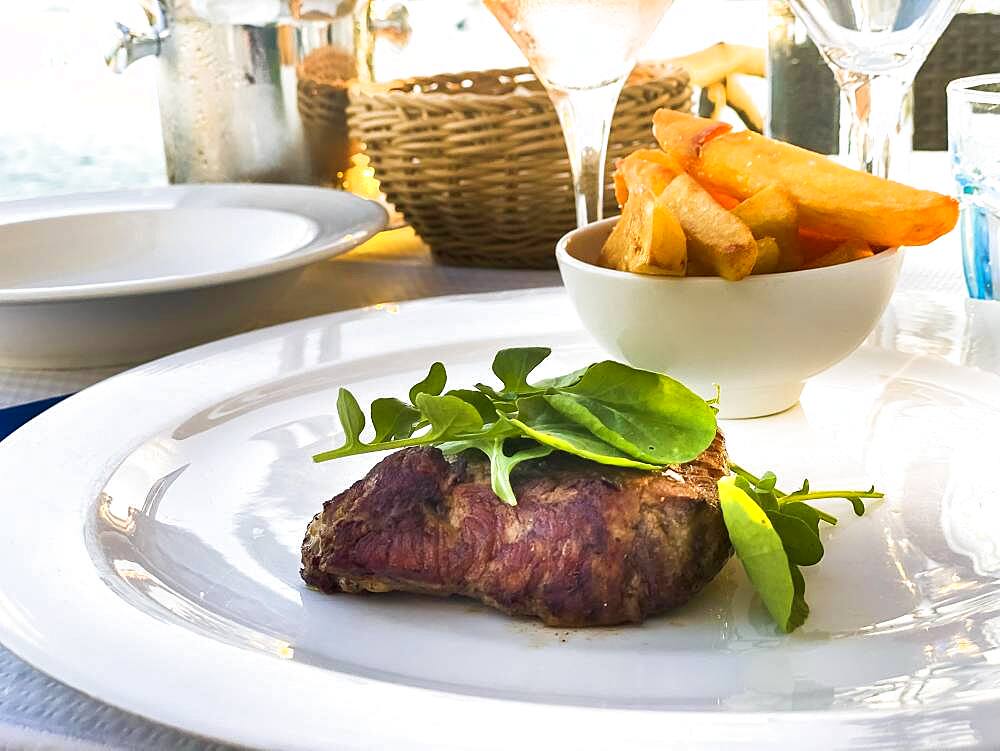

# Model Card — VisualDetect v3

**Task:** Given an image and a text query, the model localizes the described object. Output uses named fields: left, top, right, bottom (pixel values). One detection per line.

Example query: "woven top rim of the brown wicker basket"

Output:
left=349, top=63, right=690, bottom=105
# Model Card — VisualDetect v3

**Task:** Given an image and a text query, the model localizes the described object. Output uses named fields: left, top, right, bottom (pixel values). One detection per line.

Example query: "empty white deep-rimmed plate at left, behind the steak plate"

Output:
left=0, top=185, right=386, bottom=368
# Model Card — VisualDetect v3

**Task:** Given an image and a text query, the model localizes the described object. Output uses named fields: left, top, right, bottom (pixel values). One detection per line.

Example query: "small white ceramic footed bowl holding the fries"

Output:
left=556, top=218, right=903, bottom=418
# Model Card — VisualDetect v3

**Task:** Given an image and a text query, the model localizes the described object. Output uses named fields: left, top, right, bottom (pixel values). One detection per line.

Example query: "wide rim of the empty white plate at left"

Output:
left=0, top=183, right=389, bottom=304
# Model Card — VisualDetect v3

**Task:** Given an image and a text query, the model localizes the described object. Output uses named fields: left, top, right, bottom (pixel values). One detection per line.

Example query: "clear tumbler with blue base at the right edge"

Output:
left=948, top=74, right=1000, bottom=300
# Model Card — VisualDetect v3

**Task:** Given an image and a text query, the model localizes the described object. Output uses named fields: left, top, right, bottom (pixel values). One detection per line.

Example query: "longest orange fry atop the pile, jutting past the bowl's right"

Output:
left=653, top=109, right=958, bottom=246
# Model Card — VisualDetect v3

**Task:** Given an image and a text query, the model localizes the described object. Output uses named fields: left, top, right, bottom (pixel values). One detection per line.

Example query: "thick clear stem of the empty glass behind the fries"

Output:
left=835, top=69, right=913, bottom=177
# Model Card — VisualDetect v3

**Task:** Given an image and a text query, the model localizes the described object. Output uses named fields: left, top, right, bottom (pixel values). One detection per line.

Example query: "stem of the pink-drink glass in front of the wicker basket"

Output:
left=549, top=77, right=625, bottom=227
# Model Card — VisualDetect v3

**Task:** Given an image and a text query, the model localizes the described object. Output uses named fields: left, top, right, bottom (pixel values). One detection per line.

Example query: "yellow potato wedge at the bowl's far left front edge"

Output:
left=597, top=190, right=687, bottom=276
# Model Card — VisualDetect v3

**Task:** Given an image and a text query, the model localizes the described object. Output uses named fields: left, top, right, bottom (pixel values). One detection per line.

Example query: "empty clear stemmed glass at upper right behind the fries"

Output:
left=790, top=0, right=961, bottom=177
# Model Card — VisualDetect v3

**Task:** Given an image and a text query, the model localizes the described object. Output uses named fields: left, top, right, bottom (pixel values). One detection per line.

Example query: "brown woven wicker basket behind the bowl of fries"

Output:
left=348, top=66, right=691, bottom=268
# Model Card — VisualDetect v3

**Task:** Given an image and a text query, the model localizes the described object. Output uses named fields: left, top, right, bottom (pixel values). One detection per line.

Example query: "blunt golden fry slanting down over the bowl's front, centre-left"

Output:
left=660, top=175, right=757, bottom=280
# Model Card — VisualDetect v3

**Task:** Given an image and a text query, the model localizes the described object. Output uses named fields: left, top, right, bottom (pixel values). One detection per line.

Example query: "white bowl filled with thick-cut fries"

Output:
left=556, top=110, right=958, bottom=418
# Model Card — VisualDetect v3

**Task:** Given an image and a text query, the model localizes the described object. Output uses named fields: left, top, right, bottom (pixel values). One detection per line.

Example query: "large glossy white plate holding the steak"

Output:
left=0, top=289, right=1000, bottom=751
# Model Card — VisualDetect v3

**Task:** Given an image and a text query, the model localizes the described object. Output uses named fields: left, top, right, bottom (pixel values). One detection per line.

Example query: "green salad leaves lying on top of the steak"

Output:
left=313, top=347, right=688, bottom=488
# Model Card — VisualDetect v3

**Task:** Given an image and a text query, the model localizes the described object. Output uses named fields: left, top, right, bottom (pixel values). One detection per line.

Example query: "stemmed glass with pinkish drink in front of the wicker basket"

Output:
left=485, top=0, right=673, bottom=227
